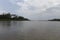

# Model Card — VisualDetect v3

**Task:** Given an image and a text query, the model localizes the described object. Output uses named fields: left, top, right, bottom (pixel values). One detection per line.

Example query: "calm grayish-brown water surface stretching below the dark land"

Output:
left=0, top=21, right=60, bottom=40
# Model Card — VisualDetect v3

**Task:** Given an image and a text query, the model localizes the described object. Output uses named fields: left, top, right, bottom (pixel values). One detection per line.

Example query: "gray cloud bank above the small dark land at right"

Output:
left=36, top=5, right=60, bottom=20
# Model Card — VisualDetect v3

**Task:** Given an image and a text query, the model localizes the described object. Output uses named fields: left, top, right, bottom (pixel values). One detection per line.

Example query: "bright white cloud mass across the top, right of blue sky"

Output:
left=9, top=0, right=60, bottom=17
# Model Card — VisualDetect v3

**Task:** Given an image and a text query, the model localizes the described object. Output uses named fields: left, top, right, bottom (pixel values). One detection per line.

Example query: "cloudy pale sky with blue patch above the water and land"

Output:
left=0, top=0, right=60, bottom=20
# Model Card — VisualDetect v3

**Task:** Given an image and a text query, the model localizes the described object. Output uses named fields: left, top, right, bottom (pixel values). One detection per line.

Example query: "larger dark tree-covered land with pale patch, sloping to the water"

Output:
left=0, top=13, right=29, bottom=21
